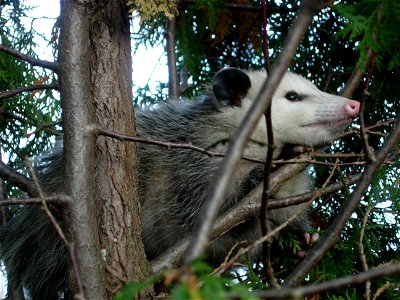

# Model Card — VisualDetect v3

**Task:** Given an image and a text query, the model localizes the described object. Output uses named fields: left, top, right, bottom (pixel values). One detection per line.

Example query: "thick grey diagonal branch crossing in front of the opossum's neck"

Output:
left=186, top=0, right=321, bottom=263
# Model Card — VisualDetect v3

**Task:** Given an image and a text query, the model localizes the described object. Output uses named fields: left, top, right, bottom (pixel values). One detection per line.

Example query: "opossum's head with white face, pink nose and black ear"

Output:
left=213, top=68, right=360, bottom=146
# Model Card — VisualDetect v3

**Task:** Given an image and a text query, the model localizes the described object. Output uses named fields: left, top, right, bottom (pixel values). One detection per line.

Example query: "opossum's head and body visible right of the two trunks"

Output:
left=137, top=69, right=359, bottom=262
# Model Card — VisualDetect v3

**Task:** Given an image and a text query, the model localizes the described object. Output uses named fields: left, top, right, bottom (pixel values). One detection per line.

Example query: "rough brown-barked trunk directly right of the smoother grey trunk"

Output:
left=90, top=1, right=152, bottom=296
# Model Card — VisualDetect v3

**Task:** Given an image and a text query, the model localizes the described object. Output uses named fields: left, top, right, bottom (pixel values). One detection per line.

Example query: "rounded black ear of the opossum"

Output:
left=213, top=68, right=251, bottom=106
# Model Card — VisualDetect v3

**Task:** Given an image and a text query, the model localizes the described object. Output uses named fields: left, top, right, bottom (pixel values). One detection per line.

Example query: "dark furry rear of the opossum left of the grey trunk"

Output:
left=0, top=146, right=67, bottom=300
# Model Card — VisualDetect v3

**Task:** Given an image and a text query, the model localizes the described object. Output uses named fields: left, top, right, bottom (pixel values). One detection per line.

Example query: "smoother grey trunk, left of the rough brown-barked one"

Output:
left=59, top=0, right=106, bottom=299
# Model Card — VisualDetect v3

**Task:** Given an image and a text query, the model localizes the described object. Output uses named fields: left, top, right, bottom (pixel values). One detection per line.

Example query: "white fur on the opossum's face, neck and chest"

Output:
left=208, top=71, right=359, bottom=234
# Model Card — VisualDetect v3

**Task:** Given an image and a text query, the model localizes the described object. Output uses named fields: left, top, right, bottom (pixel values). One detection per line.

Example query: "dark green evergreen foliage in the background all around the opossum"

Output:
left=0, top=0, right=400, bottom=299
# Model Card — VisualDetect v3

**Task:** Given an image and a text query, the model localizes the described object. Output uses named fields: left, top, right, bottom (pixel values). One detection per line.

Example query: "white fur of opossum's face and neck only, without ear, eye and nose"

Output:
left=219, top=71, right=359, bottom=157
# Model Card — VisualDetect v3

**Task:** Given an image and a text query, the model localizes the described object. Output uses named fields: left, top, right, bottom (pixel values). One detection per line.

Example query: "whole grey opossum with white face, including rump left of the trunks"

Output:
left=0, top=68, right=359, bottom=299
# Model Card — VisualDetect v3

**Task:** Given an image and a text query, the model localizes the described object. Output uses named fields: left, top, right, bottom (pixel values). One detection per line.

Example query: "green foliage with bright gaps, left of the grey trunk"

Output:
left=0, top=1, right=61, bottom=176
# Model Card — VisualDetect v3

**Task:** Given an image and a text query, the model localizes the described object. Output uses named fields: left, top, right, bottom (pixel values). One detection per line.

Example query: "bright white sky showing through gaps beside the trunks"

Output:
left=0, top=0, right=168, bottom=299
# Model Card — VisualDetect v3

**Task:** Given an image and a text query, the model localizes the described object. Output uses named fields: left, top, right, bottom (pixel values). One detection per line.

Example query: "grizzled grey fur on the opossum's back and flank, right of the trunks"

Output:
left=137, top=102, right=238, bottom=257
